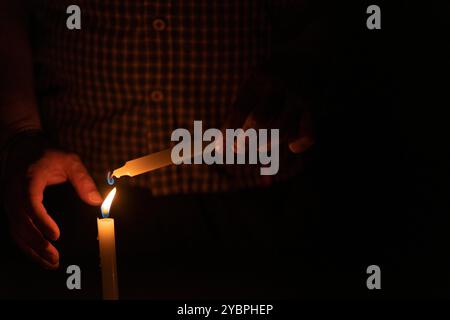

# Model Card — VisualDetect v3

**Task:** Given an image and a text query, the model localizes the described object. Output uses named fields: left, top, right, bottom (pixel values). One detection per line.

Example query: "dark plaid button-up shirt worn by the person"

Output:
left=31, top=0, right=306, bottom=195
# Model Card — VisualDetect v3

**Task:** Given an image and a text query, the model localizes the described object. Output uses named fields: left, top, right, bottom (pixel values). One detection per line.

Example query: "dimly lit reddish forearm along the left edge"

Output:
left=0, top=1, right=41, bottom=147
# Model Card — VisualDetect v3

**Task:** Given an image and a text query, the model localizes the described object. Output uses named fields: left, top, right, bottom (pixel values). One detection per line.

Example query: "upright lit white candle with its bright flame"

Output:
left=97, top=188, right=119, bottom=300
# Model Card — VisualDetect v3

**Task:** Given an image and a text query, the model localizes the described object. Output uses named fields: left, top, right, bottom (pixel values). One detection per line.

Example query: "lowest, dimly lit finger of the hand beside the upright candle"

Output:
left=11, top=215, right=59, bottom=269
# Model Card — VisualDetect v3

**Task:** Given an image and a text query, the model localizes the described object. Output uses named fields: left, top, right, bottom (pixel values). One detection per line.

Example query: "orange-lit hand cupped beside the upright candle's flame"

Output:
left=5, top=136, right=102, bottom=269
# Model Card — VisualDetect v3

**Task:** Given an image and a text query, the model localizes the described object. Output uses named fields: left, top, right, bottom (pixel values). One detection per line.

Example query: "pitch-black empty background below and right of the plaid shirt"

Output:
left=0, top=1, right=450, bottom=299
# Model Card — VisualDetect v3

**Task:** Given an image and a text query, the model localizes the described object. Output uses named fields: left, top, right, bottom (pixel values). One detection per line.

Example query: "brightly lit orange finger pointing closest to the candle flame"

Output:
left=66, top=155, right=103, bottom=205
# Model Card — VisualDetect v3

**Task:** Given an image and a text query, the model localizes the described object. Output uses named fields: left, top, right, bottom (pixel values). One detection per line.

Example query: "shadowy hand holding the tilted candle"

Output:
left=224, top=64, right=314, bottom=154
